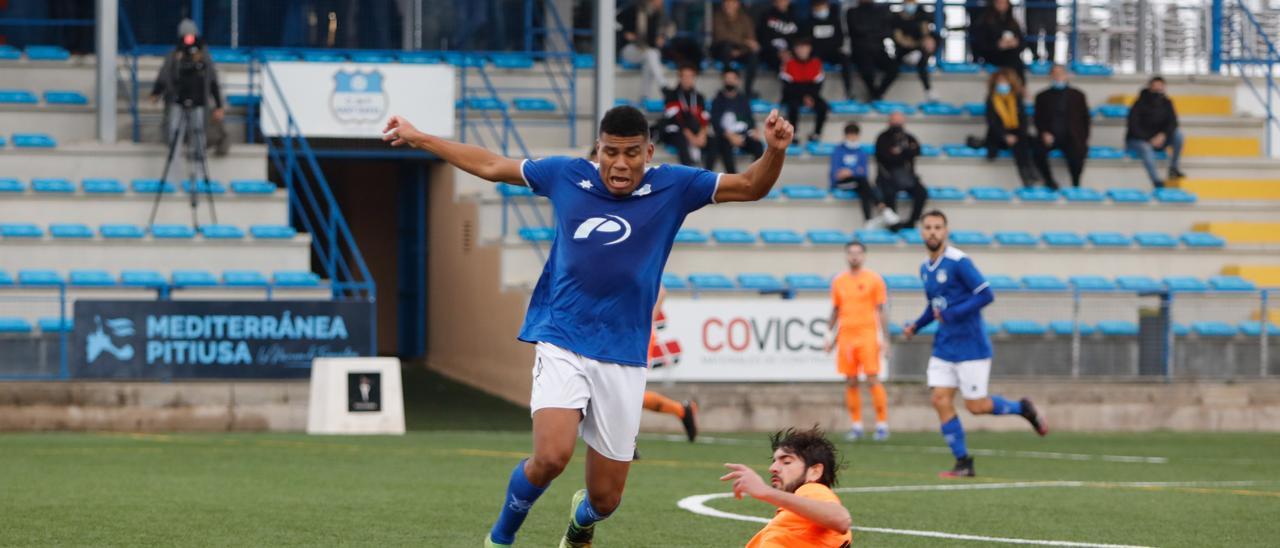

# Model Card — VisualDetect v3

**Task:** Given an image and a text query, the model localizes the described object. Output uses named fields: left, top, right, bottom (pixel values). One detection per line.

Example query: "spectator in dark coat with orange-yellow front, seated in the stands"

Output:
left=986, top=67, right=1039, bottom=187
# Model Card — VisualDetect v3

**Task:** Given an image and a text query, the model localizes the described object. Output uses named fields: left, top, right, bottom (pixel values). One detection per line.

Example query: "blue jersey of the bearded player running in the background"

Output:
left=920, top=246, right=991, bottom=362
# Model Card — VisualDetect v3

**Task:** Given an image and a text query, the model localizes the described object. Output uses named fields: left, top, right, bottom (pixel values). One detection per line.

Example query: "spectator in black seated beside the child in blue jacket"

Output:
left=876, top=111, right=929, bottom=232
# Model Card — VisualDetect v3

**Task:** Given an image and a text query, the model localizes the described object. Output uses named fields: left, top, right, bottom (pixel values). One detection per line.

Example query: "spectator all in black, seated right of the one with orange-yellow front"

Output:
left=1033, top=65, right=1092, bottom=189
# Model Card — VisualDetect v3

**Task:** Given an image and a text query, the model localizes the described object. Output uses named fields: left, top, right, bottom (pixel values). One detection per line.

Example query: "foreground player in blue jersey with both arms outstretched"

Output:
left=383, top=106, right=795, bottom=547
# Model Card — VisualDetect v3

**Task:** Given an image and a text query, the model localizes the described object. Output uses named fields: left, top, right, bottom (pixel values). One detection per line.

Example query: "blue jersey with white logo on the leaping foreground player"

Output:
left=520, top=156, right=719, bottom=367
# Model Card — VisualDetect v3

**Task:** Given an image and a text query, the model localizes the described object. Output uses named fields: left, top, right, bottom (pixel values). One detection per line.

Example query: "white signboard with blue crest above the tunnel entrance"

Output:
left=261, top=61, right=454, bottom=138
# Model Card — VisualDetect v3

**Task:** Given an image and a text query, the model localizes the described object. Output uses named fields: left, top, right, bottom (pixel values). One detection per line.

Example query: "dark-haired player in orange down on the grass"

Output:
left=721, top=426, right=854, bottom=548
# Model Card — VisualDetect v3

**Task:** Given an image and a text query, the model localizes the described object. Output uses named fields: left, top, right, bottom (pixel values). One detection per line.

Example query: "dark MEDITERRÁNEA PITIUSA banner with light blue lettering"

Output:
left=69, top=301, right=374, bottom=379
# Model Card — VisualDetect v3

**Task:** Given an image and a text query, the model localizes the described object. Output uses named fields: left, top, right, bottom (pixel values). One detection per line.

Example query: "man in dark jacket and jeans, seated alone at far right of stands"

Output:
left=1124, top=76, right=1187, bottom=188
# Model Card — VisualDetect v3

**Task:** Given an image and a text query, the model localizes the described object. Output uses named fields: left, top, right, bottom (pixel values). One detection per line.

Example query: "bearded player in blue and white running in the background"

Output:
left=902, top=210, right=1048, bottom=478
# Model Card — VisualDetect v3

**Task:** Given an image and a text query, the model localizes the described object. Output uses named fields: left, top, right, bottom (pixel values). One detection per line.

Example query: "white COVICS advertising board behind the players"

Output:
left=649, top=298, right=841, bottom=382
